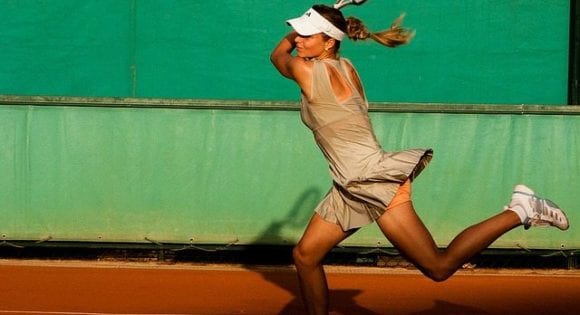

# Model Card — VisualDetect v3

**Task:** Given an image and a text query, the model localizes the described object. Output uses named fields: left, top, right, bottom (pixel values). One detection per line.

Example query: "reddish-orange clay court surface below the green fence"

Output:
left=0, top=260, right=580, bottom=315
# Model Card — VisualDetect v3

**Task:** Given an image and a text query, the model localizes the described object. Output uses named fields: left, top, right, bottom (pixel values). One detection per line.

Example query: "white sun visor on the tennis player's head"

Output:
left=286, top=8, right=346, bottom=41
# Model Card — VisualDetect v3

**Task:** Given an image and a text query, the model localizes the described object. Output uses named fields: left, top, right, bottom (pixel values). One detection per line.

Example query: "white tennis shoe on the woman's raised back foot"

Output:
left=507, top=185, right=570, bottom=230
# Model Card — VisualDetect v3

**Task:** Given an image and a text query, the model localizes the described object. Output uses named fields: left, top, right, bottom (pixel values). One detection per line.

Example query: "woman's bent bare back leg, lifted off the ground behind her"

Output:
left=377, top=201, right=521, bottom=281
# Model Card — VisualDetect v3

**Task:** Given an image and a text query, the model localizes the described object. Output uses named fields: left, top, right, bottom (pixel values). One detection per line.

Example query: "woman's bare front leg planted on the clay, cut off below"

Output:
left=292, top=213, right=355, bottom=314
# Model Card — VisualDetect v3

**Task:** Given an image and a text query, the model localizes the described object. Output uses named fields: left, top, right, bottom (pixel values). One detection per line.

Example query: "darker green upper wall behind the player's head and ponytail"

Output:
left=0, top=0, right=569, bottom=105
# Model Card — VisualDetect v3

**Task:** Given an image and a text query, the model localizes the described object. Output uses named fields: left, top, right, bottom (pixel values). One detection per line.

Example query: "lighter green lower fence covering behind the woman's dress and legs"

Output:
left=0, top=100, right=580, bottom=249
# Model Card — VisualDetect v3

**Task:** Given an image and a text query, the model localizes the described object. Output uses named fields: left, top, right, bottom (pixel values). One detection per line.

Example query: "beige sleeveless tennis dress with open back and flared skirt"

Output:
left=300, top=58, right=433, bottom=231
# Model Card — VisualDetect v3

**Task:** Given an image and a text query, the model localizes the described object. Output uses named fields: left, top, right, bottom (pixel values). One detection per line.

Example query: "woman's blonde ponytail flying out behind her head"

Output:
left=346, top=14, right=415, bottom=47
